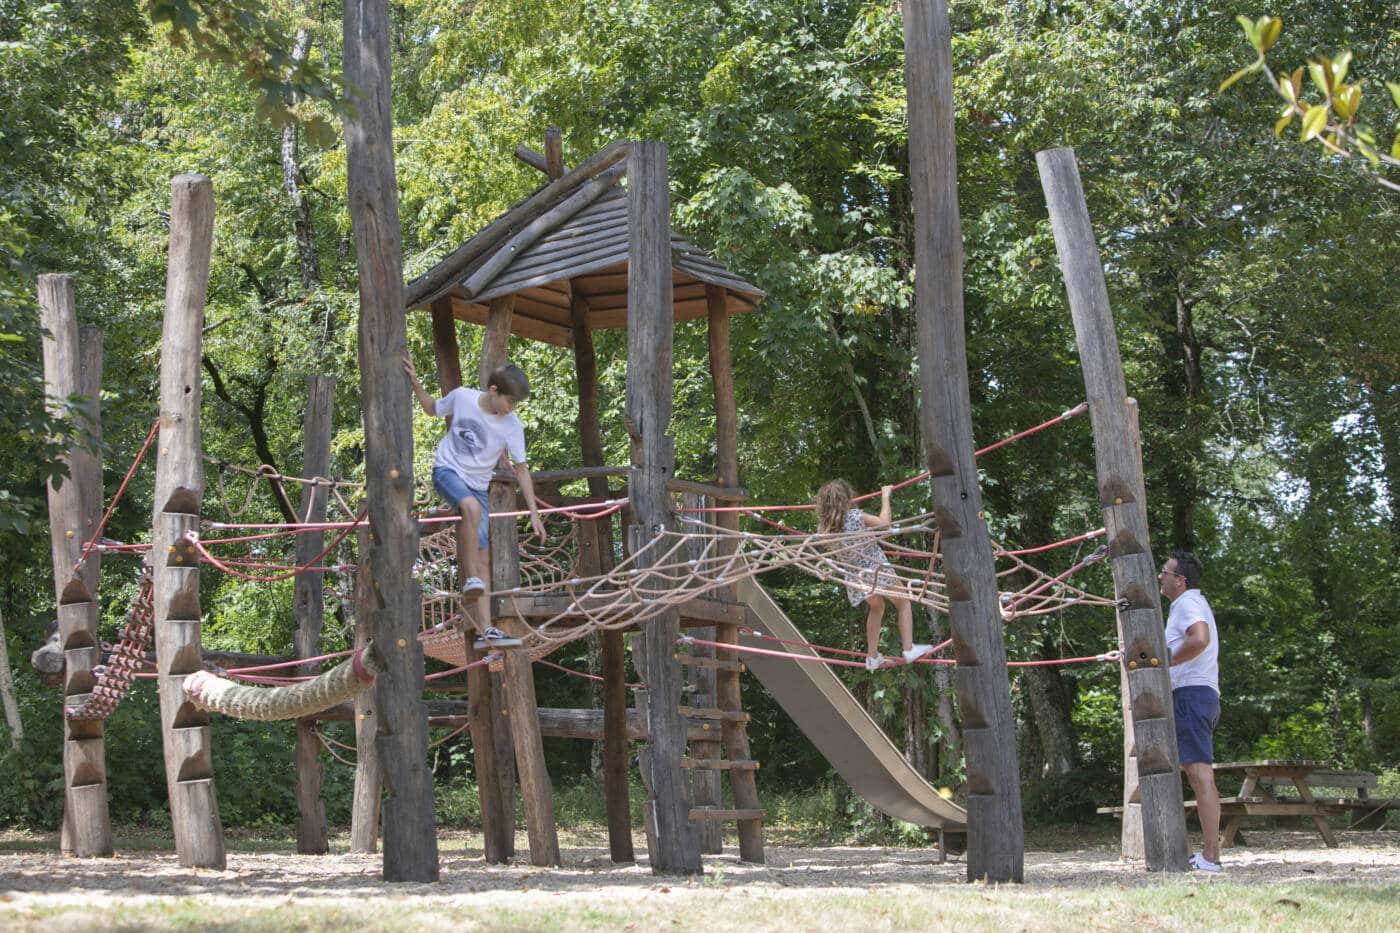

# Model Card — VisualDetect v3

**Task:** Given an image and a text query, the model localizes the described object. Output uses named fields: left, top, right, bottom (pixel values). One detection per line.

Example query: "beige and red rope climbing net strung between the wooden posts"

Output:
left=69, top=392, right=1116, bottom=719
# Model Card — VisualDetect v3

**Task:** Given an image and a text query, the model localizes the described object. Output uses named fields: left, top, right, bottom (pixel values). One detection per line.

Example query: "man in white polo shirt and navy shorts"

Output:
left=1156, top=551, right=1221, bottom=871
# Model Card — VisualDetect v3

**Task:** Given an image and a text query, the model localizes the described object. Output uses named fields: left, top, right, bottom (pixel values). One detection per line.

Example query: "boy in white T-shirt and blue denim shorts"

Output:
left=403, top=354, right=545, bottom=647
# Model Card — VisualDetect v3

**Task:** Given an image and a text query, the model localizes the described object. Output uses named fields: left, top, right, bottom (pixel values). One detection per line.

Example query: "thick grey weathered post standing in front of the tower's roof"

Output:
left=626, top=141, right=701, bottom=874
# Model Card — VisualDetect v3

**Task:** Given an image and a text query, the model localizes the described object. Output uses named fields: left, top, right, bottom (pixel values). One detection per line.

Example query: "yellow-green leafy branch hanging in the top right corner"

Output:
left=1219, top=15, right=1400, bottom=192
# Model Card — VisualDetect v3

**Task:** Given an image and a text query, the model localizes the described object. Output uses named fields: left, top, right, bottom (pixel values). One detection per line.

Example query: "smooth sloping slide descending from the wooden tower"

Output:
left=738, top=577, right=967, bottom=832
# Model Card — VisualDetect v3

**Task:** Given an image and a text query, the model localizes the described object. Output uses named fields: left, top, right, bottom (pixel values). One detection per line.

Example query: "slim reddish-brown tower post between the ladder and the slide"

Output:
left=706, top=286, right=763, bottom=862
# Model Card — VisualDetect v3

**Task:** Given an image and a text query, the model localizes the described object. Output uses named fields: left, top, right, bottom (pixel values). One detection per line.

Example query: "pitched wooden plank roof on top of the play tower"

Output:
left=405, top=141, right=763, bottom=346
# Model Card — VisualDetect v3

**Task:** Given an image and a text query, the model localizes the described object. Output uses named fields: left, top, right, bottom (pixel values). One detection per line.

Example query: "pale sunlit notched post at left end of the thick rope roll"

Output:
left=151, top=175, right=224, bottom=870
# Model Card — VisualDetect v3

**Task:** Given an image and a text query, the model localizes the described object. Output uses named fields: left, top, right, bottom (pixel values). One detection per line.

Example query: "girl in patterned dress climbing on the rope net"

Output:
left=816, top=479, right=932, bottom=671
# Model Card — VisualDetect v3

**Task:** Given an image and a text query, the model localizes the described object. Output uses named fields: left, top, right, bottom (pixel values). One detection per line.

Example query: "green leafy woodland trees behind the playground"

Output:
left=0, top=0, right=1400, bottom=835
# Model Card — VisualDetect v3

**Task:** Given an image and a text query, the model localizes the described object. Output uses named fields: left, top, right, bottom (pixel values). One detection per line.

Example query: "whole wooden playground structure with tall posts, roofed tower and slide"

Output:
left=41, top=3, right=1186, bottom=880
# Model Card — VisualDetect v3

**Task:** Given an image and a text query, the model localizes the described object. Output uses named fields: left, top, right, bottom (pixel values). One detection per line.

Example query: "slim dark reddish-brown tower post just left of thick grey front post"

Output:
left=568, top=288, right=637, bottom=863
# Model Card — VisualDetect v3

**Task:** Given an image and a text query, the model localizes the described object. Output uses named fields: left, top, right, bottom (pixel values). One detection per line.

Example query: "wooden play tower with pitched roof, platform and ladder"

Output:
left=405, top=129, right=763, bottom=873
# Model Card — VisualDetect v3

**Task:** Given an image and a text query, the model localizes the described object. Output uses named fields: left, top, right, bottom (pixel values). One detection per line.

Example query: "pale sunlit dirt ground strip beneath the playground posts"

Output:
left=0, top=829, right=1400, bottom=909
